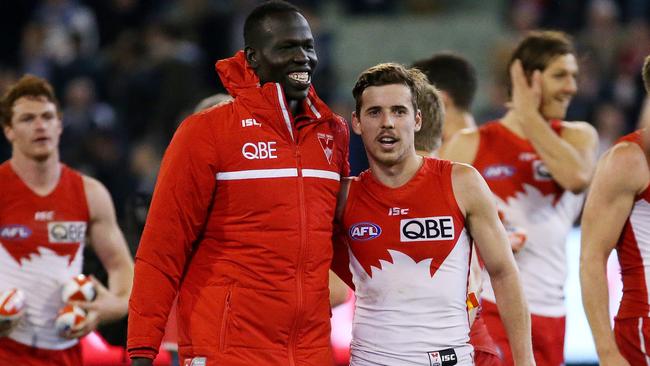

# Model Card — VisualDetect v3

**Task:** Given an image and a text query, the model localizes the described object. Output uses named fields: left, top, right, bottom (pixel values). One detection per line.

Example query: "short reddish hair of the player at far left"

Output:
left=0, top=74, right=59, bottom=126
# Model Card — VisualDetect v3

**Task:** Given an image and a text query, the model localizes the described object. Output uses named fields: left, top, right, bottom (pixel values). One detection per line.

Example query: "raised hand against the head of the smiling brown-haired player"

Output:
left=508, top=60, right=542, bottom=123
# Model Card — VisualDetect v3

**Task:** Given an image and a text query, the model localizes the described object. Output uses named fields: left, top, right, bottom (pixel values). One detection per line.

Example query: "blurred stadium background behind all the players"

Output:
left=0, top=0, right=650, bottom=364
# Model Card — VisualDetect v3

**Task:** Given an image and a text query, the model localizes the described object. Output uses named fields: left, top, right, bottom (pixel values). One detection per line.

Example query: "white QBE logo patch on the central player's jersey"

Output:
left=399, top=216, right=455, bottom=242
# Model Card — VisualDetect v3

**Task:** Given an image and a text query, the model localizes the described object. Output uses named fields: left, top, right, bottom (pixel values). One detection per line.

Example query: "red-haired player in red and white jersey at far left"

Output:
left=0, top=76, right=133, bottom=366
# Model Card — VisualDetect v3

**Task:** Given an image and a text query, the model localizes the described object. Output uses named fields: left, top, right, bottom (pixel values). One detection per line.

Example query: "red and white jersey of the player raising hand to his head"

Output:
left=472, top=121, right=584, bottom=317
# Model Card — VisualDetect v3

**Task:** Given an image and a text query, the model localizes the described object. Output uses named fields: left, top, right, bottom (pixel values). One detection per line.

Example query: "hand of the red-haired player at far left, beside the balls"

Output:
left=63, top=276, right=128, bottom=339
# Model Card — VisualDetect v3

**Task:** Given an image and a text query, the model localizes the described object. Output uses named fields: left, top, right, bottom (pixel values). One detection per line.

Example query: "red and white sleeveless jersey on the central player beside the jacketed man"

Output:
left=342, top=158, right=473, bottom=366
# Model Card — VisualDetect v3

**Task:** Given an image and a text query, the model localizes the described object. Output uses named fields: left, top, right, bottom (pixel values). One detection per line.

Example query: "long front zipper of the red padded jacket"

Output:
left=289, top=147, right=307, bottom=366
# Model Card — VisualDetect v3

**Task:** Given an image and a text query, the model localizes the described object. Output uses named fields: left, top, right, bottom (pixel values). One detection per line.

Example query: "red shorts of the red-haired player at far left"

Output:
left=0, top=337, right=83, bottom=366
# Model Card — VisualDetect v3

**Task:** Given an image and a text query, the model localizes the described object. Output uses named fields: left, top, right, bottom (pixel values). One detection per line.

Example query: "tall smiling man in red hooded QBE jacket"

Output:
left=128, top=2, right=349, bottom=366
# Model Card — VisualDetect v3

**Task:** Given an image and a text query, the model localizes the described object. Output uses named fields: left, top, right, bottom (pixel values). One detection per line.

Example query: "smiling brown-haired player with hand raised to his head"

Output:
left=441, top=31, right=597, bottom=366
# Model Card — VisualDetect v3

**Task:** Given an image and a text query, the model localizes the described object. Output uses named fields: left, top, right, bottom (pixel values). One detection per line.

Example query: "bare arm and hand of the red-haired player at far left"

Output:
left=69, top=176, right=133, bottom=338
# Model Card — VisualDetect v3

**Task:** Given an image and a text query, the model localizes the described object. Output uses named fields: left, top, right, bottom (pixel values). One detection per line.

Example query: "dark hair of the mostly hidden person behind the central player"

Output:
left=413, top=52, right=478, bottom=111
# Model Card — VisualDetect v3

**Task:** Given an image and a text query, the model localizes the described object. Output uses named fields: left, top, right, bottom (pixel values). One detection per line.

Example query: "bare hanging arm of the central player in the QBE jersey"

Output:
left=452, top=164, right=535, bottom=365
